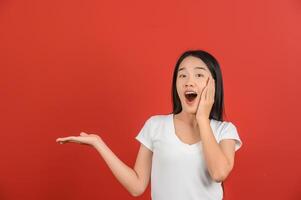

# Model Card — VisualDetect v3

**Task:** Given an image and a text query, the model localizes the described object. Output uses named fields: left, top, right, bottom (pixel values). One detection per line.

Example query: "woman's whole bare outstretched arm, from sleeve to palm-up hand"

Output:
left=57, top=133, right=152, bottom=196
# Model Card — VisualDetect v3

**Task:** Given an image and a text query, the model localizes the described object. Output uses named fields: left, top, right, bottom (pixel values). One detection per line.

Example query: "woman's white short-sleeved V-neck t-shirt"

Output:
left=136, top=114, right=242, bottom=200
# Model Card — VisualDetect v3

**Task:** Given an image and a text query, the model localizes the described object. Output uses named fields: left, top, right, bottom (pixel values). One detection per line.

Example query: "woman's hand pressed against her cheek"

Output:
left=196, top=75, right=215, bottom=120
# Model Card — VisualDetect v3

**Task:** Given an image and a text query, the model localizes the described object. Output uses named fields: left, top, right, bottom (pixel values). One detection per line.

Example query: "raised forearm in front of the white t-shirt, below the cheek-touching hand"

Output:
left=198, top=119, right=230, bottom=182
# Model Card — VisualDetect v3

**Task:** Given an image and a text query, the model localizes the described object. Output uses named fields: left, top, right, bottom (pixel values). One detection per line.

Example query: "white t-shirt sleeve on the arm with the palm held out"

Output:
left=136, top=117, right=153, bottom=151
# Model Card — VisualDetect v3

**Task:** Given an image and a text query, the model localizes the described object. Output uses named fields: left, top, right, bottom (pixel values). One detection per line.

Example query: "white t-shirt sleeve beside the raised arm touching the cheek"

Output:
left=219, top=122, right=242, bottom=151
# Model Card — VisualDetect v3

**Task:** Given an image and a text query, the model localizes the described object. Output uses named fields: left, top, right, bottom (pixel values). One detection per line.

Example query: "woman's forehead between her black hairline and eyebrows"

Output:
left=178, top=56, right=209, bottom=72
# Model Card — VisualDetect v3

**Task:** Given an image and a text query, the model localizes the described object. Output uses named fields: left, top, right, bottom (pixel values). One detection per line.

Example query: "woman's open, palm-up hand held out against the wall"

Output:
left=56, top=132, right=102, bottom=147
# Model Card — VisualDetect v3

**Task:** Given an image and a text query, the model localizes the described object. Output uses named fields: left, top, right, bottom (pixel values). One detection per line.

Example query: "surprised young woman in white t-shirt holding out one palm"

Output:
left=56, top=50, right=242, bottom=200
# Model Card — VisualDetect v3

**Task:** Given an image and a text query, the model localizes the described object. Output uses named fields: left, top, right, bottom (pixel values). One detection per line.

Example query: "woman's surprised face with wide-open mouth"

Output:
left=176, top=56, right=212, bottom=114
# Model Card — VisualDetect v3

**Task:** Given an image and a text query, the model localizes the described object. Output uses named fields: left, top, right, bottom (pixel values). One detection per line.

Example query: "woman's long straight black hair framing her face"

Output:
left=171, top=50, right=225, bottom=197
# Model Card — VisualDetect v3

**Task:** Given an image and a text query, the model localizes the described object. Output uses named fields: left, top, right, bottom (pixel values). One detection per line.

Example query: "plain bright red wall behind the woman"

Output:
left=0, top=0, right=301, bottom=200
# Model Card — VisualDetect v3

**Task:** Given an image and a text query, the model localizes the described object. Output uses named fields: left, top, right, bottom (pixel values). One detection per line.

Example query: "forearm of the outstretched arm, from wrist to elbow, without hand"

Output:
left=95, top=141, right=140, bottom=196
